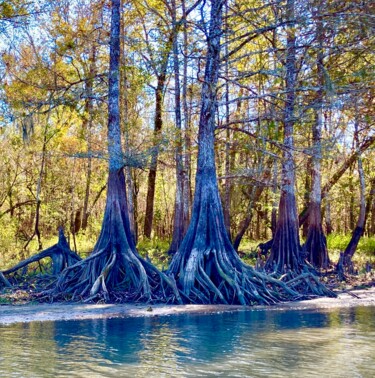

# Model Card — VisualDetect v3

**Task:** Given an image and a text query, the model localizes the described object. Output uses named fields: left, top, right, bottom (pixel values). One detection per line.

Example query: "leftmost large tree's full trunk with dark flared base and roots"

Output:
left=54, top=0, right=181, bottom=302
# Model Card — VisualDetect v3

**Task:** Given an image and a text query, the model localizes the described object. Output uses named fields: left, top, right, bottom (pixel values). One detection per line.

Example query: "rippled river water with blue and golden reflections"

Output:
left=0, top=307, right=375, bottom=377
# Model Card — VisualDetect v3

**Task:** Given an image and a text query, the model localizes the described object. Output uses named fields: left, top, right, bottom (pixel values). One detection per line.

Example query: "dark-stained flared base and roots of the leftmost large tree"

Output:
left=48, top=170, right=182, bottom=303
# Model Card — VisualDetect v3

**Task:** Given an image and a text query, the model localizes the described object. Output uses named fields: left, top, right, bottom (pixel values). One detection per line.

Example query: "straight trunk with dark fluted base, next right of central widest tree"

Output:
left=266, top=0, right=302, bottom=273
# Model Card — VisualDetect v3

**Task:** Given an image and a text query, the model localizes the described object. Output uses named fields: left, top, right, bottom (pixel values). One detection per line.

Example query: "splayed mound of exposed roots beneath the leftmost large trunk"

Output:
left=50, top=246, right=182, bottom=303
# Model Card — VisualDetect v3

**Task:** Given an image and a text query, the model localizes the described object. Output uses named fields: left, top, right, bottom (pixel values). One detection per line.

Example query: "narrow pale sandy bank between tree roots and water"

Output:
left=0, top=287, right=375, bottom=326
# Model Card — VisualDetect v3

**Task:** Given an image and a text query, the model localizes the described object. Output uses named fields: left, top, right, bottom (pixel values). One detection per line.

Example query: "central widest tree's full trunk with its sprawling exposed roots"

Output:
left=168, top=0, right=332, bottom=304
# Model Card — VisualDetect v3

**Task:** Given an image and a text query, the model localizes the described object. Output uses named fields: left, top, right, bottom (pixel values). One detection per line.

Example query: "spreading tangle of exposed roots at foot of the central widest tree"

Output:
left=170, top=245, right=335, bottom=305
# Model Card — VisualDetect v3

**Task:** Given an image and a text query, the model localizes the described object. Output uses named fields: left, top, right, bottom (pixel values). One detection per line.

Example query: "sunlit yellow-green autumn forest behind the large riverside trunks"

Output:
left=0, top=0, right=375, bottom=276
